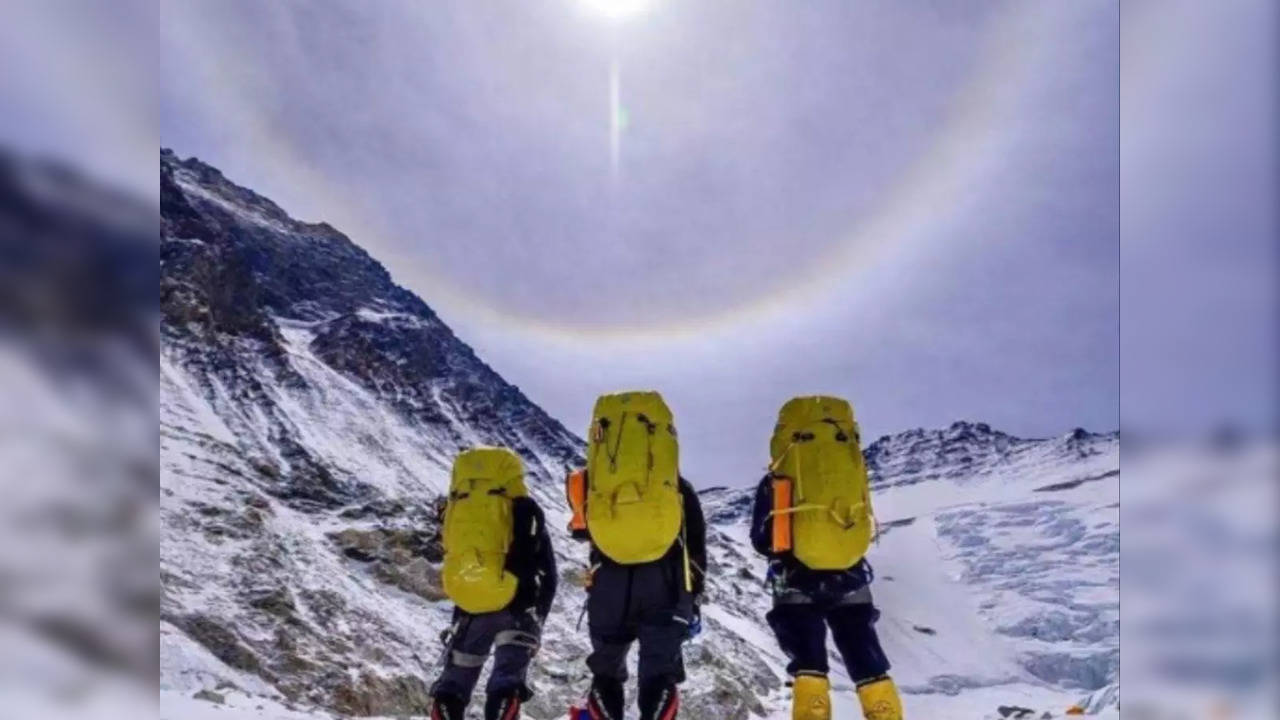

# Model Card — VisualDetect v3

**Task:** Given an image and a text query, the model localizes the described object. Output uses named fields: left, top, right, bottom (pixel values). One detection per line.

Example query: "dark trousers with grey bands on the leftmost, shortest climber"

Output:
left=431, top=610, right=539, bottom=702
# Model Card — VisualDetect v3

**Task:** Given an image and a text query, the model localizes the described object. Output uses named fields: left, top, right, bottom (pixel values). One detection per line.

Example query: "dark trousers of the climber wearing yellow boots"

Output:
left=765, top=585, right=890, bottom=683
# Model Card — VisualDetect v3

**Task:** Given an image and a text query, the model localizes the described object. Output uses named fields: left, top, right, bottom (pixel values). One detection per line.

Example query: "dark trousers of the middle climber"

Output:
left=586, top=559, right=694, bottom=685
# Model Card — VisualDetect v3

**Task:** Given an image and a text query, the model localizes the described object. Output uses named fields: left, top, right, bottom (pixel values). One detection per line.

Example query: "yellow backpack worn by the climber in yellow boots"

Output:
left=769, top=396, right=874, bottom=570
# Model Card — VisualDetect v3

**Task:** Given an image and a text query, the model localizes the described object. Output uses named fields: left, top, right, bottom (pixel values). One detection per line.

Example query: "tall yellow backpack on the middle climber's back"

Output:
left=586, top=392, right=685, bottom=565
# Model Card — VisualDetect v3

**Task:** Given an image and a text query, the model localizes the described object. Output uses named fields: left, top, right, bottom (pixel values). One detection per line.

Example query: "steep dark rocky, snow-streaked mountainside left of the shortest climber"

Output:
left=160, top=146, right=580, bottom=715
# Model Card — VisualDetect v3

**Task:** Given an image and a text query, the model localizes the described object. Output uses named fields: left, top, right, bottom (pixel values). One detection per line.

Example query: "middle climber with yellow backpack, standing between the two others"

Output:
left=567, top=392, right=707, bottom=720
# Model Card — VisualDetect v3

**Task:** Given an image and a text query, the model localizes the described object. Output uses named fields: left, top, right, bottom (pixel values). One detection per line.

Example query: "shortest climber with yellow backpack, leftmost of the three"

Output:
left=431, top=447, right=556, bottom=720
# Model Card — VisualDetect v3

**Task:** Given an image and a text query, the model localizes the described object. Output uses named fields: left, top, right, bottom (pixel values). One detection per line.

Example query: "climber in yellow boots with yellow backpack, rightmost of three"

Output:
left=751, top=396, right=902, bottom=720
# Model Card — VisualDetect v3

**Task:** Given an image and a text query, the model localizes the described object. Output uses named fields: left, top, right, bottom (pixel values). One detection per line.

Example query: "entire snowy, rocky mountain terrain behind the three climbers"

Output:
left=160, top=151, right=1119, bottom=720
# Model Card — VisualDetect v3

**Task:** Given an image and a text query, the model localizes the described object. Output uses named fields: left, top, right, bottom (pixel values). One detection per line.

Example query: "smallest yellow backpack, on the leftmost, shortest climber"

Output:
left=442, top=447, right=529, bottom=612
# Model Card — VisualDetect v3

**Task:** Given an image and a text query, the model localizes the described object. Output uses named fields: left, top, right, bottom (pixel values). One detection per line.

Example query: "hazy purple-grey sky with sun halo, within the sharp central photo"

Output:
left=160, top=0, right=1119, bottom=486
